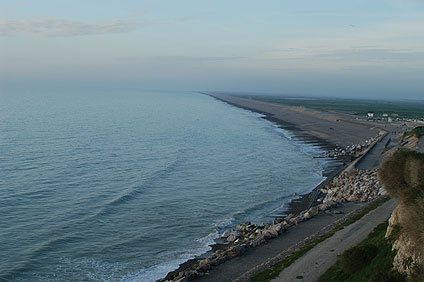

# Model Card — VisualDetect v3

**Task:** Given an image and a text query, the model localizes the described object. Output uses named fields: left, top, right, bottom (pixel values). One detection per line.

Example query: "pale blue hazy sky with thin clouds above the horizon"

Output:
left=0, top=0, right=424, bottom=99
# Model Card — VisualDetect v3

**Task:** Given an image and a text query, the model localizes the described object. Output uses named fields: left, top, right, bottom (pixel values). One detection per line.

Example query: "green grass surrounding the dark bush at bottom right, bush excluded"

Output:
left=318, top=222, right=406, bottom=282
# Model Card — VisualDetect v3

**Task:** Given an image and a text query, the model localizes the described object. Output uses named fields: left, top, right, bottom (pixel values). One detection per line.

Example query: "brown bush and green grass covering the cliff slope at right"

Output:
left=319, top=151, right=424, bottom=282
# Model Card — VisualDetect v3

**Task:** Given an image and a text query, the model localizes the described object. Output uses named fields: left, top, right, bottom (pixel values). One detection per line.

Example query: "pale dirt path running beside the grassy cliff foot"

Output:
left=272, top=199, right=397, bottom=282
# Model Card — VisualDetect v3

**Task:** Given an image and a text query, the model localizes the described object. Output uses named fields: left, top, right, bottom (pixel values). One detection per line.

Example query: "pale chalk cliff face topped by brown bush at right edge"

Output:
left=379, top=151, right=424, bottom=281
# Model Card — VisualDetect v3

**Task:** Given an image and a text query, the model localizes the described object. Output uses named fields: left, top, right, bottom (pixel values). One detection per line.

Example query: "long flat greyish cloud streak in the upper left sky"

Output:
left=0, top=18, right=150, bottom=37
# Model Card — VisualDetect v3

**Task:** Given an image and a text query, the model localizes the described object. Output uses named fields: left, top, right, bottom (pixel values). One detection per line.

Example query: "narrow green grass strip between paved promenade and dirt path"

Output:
left=251, top=197, right=389, bottom=282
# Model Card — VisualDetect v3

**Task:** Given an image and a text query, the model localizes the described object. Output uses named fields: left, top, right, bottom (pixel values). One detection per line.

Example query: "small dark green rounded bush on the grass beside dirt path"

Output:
left=340, top=245, right=378, bottom=274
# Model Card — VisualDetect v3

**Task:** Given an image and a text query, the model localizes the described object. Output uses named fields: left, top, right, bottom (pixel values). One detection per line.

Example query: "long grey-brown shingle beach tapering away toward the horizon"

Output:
left=207, top=94, right=384, bottom=213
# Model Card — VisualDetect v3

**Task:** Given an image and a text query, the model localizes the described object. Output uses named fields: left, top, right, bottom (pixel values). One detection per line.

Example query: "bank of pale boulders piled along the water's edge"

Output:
left=158, top=169, right=383, bottom=282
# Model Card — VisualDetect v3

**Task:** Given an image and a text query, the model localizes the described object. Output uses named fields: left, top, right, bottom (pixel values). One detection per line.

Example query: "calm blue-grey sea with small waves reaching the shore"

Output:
left=0, top=90, right=322, bottom=281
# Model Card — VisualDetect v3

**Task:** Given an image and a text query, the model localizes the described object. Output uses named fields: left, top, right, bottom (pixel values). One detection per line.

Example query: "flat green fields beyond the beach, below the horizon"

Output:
left=238, top=95, right=424, bottom=119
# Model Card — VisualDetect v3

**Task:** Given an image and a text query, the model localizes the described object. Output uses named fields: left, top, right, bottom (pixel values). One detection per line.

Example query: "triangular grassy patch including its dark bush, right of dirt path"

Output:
left=318, top=222, right=406, bottom=282
